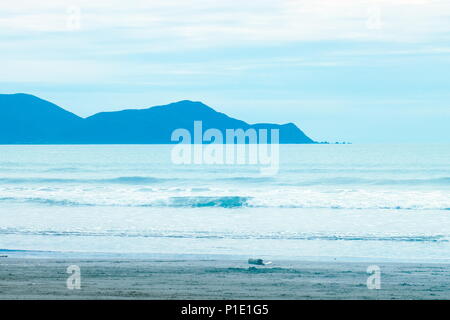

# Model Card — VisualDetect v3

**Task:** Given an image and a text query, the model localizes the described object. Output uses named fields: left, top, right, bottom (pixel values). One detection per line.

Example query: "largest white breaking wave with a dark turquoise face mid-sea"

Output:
left=0, top=192, right=450, bottom=211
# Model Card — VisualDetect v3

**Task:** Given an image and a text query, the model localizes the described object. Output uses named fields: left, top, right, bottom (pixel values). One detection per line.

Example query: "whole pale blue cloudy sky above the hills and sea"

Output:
left=0, top=0, right=450, bottom=143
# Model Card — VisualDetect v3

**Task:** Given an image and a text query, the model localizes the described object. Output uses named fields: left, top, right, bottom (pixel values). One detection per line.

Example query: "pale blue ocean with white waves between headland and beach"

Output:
left=0, top=144, right=450, bottom=262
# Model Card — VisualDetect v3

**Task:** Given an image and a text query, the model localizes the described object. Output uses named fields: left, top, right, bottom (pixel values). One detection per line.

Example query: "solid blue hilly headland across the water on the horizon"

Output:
left=0, top=94, right=315, bottom=144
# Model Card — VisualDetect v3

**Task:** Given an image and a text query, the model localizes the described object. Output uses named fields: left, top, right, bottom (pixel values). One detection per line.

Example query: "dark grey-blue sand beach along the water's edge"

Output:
left=0, top=256, right=450, bottom=299
